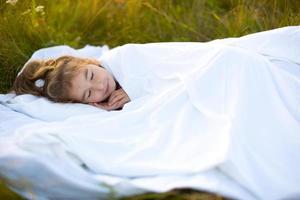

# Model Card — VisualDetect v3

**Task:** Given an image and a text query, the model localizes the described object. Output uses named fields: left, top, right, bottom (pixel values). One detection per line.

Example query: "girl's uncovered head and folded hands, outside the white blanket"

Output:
left=13, top=56, right=130, bottom=110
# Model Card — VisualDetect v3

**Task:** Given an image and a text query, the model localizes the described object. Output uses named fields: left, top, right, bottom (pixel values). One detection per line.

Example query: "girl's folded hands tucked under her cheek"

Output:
left=90, top=88, right=130, bottom=111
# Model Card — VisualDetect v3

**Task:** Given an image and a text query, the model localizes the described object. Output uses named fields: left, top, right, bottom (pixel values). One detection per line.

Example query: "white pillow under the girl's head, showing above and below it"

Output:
left=0, top=45, right=108, bottom=122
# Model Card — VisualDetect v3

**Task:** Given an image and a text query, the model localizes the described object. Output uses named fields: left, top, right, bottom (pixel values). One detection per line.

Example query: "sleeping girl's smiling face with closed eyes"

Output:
left=70, top=64, right=116, bottom=103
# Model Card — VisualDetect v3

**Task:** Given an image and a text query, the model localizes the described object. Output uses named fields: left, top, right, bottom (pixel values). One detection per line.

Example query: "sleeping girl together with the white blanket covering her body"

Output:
left=6, top=26, right=300, bottom=199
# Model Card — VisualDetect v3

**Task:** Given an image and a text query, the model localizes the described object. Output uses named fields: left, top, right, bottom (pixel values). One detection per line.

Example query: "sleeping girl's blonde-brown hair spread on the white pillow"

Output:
left=12, top=56, right=100, bottom=102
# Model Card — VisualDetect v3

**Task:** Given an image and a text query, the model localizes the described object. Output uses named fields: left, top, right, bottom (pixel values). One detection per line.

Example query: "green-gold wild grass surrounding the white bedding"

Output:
left=0, top=0, right=300, bottom=200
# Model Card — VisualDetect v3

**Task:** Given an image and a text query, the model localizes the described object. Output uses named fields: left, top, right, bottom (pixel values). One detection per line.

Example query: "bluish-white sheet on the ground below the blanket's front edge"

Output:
left=0, top=104, right=253, bottom=199
